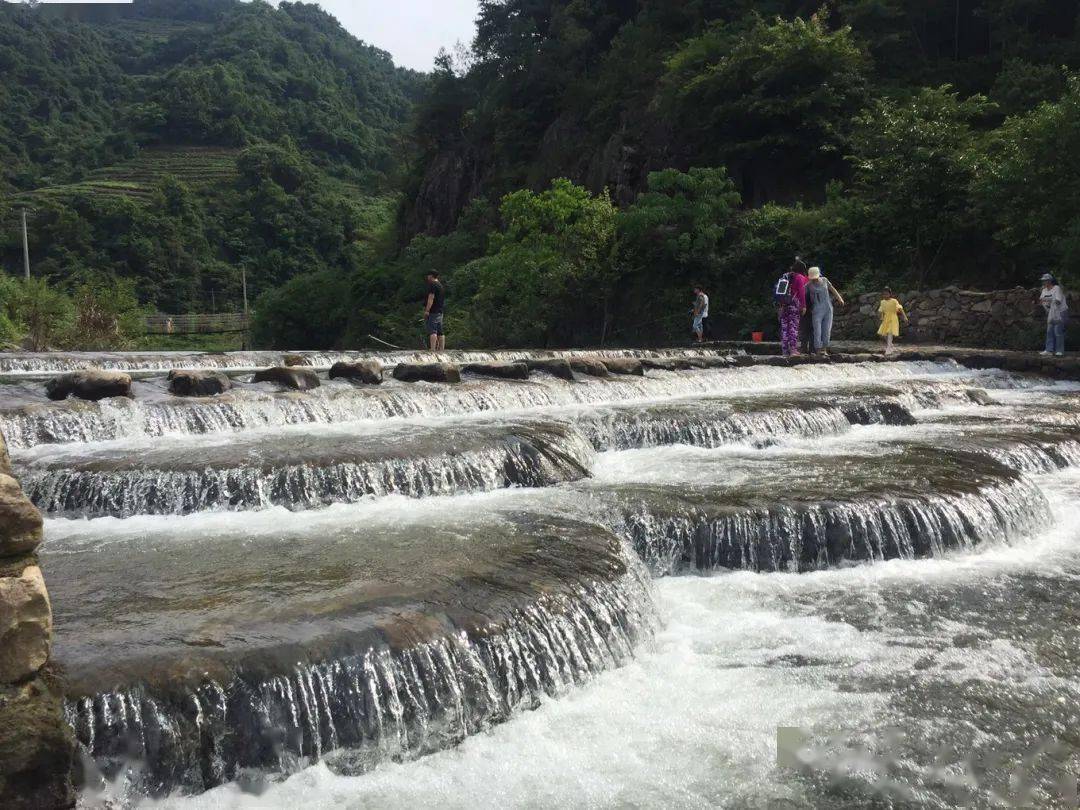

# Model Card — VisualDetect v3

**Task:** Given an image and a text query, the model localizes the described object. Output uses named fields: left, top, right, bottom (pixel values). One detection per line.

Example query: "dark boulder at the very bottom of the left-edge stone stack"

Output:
left=0, top=676, right=76, bottom=810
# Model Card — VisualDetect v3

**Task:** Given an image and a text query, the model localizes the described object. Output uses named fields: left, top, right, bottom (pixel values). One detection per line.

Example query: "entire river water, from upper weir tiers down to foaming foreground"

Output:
left=0, top=353, right=1080, bottom=808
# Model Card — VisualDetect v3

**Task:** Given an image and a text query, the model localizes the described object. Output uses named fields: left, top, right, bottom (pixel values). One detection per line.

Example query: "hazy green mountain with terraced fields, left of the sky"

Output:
left=0, top=0, right=423, bottom=326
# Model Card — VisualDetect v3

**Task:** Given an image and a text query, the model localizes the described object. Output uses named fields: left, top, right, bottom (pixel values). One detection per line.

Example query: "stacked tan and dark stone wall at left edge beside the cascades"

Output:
left=0, top=427, right=75, bottom=810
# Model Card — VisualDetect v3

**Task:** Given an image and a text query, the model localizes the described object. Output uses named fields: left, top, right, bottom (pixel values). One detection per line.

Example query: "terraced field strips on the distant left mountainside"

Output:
left=15, top=146, right=240, bottom=204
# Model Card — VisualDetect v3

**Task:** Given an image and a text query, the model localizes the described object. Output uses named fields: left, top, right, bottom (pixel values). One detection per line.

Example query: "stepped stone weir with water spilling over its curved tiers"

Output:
left=0, top=348, right=1080, bottom=807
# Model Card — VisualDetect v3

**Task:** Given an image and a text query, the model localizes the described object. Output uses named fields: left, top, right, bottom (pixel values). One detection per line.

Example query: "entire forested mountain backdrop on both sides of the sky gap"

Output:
left=0, top=0, right=1080, bottom=347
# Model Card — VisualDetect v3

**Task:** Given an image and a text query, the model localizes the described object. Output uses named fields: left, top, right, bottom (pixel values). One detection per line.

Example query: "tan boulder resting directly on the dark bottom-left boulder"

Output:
left=0, top=565, right=53, bottom=684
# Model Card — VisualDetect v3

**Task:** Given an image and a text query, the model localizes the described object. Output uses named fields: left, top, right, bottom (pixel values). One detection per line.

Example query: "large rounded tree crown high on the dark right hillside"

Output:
left=661, top=16, right=869, bottom=202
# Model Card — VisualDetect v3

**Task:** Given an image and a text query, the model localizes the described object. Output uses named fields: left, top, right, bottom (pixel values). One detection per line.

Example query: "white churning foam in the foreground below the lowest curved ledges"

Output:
left=122, top=472, right=1080, bottom=810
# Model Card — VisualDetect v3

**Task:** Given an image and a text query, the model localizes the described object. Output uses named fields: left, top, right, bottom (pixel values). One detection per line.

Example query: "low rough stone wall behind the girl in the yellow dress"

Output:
left=833, top=287, right=1080, bottom=349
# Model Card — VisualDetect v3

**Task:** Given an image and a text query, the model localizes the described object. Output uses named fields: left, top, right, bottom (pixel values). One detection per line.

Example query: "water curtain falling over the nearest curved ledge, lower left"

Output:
left=66, top=546, right=658, bottom=794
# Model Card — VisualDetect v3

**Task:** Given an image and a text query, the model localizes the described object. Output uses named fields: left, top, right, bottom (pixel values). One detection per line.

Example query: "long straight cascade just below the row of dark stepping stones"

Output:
left=0, top=362, right=972, bottom=449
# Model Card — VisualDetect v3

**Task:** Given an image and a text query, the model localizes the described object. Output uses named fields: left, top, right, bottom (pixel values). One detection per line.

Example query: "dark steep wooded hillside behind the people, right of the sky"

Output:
left=352, top=0, right=1080, bottom=343
